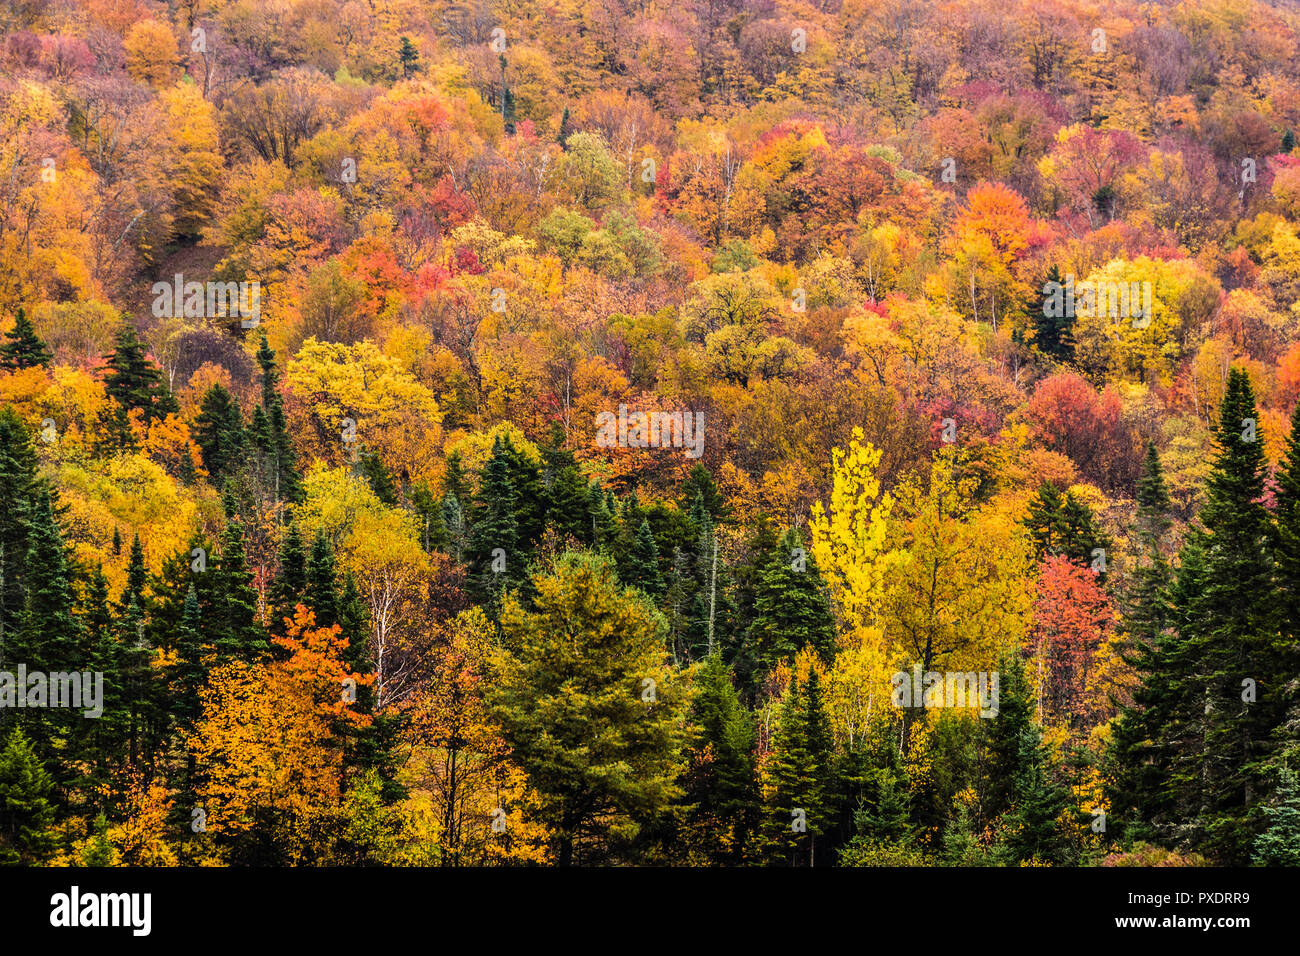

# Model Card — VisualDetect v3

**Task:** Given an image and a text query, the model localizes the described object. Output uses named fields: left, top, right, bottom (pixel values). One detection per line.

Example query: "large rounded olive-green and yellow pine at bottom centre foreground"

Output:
left=491, top=553, right=686, bottom=866
